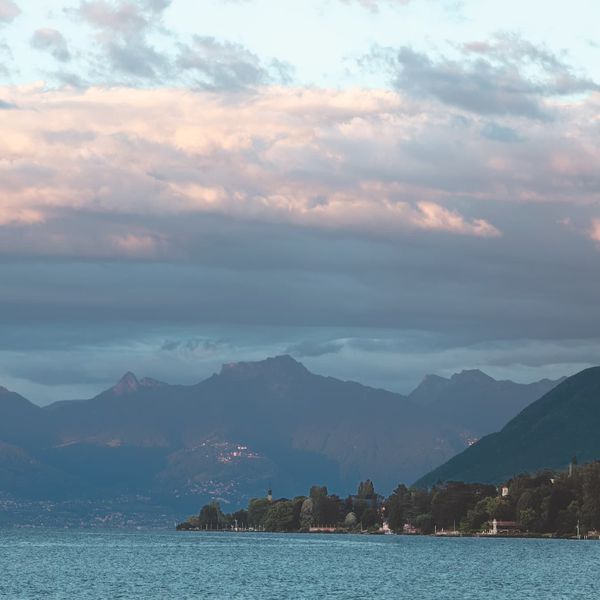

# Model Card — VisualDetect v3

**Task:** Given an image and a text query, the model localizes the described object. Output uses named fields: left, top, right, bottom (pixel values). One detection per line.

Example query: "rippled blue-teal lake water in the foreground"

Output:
left=0, top=530, right=600, bottom=600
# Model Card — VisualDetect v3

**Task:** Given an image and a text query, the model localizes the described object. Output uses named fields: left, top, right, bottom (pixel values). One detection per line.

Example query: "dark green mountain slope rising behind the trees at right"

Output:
left=417, top=367, right=600, bottom=486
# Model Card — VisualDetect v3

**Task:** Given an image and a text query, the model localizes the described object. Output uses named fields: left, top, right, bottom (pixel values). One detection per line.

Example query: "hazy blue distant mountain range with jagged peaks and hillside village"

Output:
left=0, top=356, right=557, bottom=514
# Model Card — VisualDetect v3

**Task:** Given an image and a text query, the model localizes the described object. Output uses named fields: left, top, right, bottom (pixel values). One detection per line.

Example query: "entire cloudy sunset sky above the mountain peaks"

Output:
left=0, top=0, right=600, bottom=404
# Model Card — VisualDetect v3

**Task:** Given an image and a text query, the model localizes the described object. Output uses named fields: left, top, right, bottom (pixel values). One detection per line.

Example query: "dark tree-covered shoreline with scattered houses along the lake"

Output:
left=177, top=459, right=600, bottom=537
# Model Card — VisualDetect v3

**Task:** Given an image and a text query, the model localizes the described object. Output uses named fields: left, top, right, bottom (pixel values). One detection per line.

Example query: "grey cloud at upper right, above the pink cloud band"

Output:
left=367, top=35, right=600, bottom=121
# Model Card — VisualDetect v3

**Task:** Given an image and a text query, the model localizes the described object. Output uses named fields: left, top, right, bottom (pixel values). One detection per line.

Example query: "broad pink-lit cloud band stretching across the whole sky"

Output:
left=0, top=86, right=600, bottom=256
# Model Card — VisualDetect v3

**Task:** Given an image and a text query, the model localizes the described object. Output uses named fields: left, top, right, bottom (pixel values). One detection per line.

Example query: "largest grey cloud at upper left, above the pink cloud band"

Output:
left=71, top=0, right=292, bottom=91
